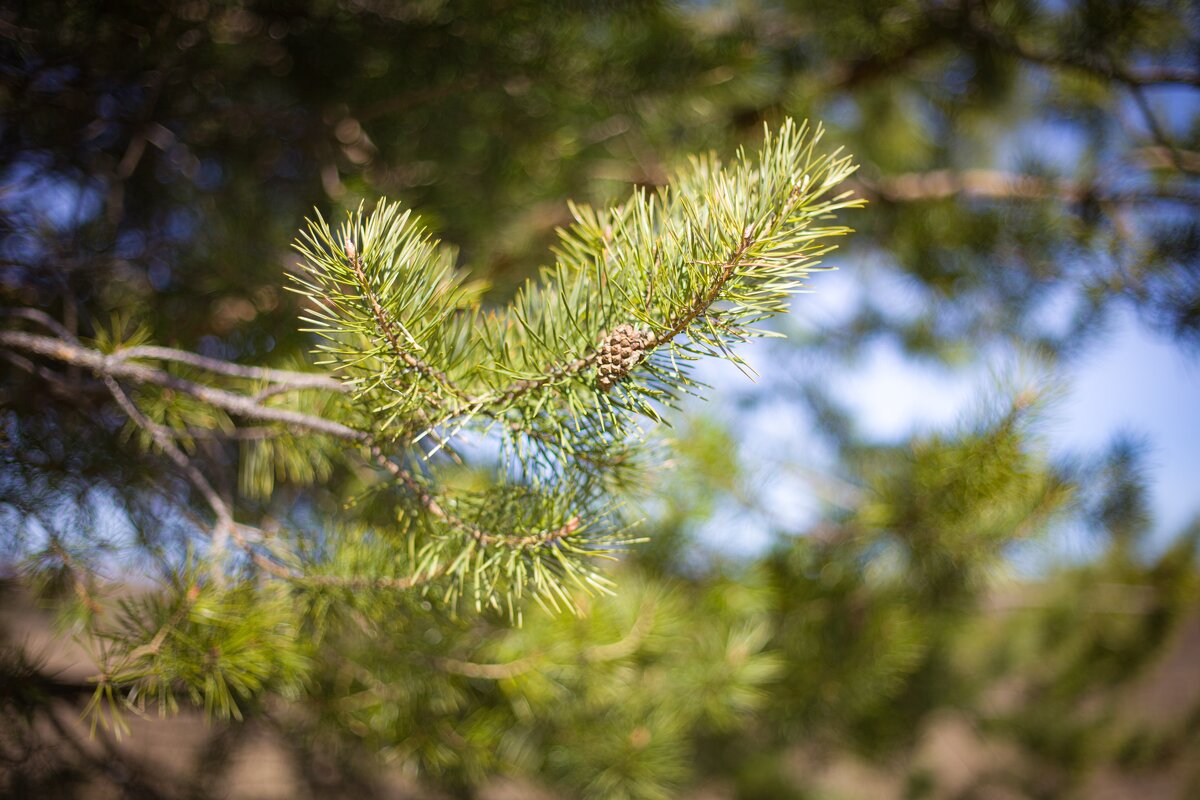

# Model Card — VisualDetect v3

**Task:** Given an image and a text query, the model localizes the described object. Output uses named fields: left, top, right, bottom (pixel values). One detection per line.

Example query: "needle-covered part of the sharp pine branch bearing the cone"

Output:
left=278, top=122, right=859, bottom=607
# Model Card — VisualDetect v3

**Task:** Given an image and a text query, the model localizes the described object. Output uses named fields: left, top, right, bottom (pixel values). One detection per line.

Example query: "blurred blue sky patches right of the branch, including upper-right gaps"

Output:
left=697, top=76, right=1200, bottom=569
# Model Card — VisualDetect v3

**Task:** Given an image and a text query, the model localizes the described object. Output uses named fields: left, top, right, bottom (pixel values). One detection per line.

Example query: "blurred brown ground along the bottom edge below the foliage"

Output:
left=0, top=584, right=1200, bottom=800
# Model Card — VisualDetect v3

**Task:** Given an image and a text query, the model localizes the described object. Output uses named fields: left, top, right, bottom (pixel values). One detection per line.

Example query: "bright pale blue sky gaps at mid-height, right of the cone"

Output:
left=695, top=269, right=1200, bottom=571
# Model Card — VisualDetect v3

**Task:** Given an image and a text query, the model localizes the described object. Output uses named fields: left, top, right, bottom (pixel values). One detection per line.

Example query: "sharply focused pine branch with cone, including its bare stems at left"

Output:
left=0, top=122, right=860, bottom=616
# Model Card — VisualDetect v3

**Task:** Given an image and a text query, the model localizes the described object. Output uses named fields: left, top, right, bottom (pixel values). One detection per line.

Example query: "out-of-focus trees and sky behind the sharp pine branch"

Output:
left=0, top=0, right=1200, bottom=799
